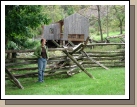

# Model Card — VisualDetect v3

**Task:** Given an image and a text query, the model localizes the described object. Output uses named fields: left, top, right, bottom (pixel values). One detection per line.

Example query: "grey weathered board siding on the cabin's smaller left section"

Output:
left=44, top=23, right=60, bottom=40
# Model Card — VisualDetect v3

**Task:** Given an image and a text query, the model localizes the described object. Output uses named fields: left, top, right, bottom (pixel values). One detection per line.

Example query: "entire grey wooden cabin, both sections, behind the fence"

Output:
left=43, top=13, right=89, bottom=47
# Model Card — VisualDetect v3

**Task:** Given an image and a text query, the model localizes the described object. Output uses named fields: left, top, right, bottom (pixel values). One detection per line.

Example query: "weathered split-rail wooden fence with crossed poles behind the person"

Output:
left=5, top=43, right=125, bottom=89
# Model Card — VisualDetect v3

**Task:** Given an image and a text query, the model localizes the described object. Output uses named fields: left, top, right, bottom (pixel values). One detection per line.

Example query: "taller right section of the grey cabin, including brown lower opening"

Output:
left=63, top=13, right=89, bottom=44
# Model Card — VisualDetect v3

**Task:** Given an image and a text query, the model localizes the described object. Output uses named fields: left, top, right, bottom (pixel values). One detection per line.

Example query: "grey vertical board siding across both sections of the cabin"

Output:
left=44, top=13, right=89, bottom=40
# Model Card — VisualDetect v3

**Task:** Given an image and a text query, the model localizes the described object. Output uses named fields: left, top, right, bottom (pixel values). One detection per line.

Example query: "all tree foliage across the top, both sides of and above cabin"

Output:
left=5, top=5, right=125, bottom=47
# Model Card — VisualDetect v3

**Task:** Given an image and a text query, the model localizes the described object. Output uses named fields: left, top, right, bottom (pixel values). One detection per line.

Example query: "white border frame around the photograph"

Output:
left=1, top=1, right=129, bottom=99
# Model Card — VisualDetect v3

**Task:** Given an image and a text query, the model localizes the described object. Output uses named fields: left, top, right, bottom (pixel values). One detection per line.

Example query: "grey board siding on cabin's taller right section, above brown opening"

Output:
left=63, top=13, right=89, bottom=40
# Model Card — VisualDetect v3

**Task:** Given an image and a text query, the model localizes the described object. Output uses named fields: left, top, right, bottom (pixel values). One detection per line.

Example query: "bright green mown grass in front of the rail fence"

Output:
left=5, top=68, right=125, bottom=95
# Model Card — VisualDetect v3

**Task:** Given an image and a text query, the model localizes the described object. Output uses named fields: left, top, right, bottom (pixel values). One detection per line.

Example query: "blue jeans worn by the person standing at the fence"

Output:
left=38, top=58, right=47, bottom=82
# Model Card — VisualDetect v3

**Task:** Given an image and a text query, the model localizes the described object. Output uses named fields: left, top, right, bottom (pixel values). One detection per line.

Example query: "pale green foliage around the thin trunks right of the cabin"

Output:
left=89, top=5, right=125, bottom=40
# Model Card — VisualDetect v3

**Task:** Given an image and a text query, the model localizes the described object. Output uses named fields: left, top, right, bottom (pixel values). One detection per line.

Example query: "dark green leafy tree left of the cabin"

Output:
left=5, top=5, right=50, bottom=45
